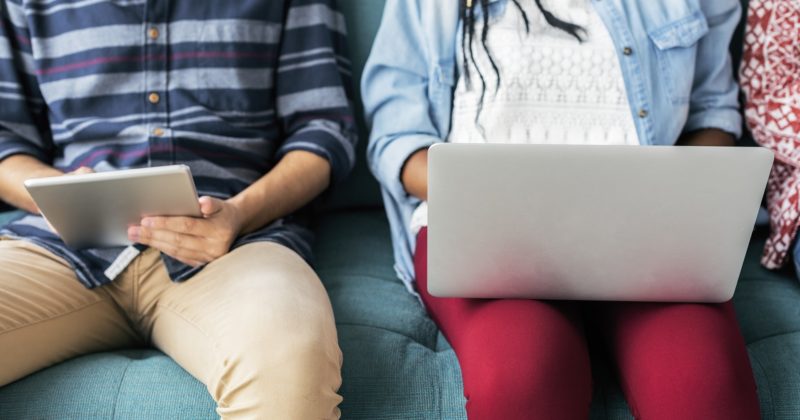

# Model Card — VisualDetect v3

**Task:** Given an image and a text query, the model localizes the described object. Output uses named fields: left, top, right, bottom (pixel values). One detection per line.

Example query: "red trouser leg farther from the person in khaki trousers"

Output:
left=595, top=302, right=760, bottom=420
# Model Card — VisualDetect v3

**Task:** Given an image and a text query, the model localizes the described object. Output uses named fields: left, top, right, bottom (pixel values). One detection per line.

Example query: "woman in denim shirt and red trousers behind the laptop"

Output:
left=362, top=0, right=759, bottom=420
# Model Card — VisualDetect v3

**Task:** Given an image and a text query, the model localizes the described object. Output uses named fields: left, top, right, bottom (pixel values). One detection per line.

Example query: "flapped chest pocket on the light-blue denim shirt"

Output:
left=647, top=10, right=709, bottom=105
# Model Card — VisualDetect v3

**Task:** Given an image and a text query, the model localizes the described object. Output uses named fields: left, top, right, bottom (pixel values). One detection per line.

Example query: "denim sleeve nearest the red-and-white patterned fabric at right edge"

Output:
left=676, top=0, right=742, bottom=138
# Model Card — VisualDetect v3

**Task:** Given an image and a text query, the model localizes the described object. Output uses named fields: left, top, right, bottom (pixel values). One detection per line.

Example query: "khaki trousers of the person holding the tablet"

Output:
left=0, top=240, right=342, bottom=420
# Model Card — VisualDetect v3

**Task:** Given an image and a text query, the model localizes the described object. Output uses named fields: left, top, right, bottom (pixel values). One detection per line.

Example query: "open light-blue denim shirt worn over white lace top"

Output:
left=362, top=0, right=742, bottom=293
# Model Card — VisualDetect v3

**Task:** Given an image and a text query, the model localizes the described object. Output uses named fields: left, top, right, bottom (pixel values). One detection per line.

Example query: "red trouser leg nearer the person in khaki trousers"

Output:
left=415, top=230, right=592, bottom=420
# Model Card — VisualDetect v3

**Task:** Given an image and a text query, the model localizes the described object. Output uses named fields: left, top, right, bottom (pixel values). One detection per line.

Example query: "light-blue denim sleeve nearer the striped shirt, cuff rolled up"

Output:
left=362, top=0, right=444, bottom=202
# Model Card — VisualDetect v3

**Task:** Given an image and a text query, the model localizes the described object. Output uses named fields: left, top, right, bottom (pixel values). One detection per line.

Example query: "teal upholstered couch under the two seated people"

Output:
left=0, top=0, right=800, bottom=420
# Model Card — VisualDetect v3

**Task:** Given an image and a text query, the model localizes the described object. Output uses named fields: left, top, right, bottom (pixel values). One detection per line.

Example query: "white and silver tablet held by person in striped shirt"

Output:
left=25, top=165, right=202, bottom=249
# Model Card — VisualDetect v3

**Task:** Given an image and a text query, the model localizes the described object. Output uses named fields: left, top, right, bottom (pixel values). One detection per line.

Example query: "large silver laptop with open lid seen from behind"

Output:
left=428, top=144, right=773, bottom=302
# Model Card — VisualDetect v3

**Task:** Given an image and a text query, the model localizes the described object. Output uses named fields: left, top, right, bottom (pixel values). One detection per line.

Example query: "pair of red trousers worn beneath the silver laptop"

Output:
left=414, top=229, right=760, bottom=420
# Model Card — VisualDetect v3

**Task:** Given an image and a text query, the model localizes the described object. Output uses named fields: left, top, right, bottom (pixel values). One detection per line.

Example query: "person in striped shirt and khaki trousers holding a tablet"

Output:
left=0, top=0, right=356, bottom=420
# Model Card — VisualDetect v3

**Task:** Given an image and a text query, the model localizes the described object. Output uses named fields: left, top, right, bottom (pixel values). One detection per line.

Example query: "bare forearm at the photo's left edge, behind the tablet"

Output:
left=0, top=155, right=63, bottom=214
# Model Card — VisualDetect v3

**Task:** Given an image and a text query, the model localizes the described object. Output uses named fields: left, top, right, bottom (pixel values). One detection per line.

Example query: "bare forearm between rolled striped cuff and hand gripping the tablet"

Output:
left=229, top=151, right=331, bottom=234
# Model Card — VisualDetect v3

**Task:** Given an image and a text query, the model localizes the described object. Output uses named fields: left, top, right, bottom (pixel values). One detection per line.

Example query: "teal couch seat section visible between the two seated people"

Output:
left=315, top=210, right=466, bottom=419
